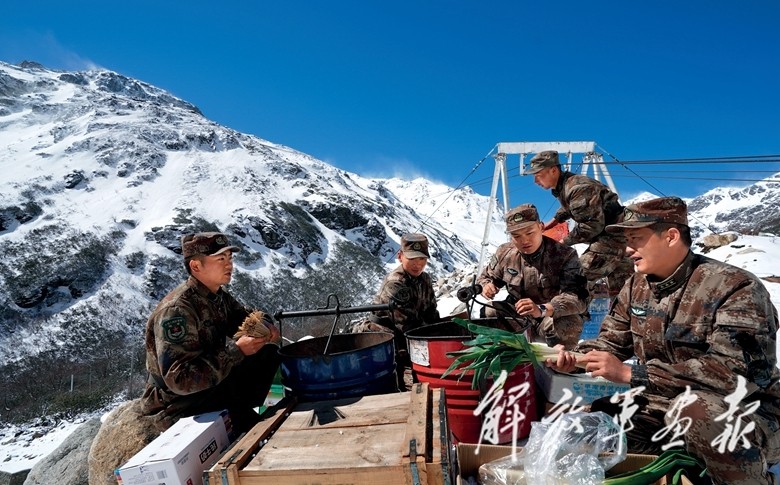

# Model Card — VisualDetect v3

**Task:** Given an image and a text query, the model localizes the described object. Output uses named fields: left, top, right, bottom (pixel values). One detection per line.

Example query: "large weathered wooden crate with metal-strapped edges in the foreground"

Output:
left=204, top=383, right=454, bottom=485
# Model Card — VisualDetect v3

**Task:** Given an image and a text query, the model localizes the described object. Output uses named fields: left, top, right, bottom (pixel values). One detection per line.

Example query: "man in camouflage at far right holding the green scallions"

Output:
left=548, top=197, right=780, bottom=485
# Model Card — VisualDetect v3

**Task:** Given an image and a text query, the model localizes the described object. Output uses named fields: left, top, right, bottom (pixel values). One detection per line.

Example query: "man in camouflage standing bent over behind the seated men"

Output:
left=525, top=150, right=634, bottom=295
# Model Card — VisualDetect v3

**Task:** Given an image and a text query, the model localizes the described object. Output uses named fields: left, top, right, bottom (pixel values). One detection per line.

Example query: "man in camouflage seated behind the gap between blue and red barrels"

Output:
left=352, top=233, right=439, bottom=391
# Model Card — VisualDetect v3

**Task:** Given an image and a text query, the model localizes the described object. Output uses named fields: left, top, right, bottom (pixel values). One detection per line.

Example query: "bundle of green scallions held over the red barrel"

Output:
left=442, top=318, right=582, bottom=389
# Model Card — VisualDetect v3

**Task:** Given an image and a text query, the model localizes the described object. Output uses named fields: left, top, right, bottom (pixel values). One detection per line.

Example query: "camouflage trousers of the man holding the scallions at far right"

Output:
left=590, top=391, right=780, bottom=485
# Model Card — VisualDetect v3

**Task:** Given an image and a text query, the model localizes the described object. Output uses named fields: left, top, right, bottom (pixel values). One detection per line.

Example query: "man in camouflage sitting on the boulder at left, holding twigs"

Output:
left=141, top=232, right=280, bottom=433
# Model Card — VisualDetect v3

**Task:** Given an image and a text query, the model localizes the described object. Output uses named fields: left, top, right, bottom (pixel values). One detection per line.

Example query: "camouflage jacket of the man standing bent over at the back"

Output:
left=552, top=172, right=625, bottom=254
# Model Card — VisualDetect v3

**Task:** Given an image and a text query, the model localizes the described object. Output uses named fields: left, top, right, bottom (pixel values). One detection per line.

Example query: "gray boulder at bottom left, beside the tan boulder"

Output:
left=24, top=418, right=100, bottom=485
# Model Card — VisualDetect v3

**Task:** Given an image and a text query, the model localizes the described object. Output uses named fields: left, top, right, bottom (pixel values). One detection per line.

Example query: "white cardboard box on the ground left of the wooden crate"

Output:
left=114, top=411, right=232, bottom=485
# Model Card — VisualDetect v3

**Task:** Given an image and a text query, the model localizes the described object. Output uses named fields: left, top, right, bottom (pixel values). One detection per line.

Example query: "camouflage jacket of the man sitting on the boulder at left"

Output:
left=142, top=276, right=249, bottom=416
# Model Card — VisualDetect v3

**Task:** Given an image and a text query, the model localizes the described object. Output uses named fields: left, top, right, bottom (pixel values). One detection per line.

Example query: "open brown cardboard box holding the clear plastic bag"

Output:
left=455, top=443, right=692, bottom=485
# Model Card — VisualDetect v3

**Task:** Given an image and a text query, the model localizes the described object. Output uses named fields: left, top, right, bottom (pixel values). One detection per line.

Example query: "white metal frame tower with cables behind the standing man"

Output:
left=477, top=141, right=620, bottom=274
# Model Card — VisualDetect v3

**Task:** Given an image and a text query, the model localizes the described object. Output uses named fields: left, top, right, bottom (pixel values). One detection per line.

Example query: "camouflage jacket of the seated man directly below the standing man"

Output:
left=477, top=236, right=588, bottom=330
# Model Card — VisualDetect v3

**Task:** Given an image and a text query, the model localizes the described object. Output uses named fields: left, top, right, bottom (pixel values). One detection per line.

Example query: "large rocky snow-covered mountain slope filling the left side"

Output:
left=0, top=63, right=506, bottom=362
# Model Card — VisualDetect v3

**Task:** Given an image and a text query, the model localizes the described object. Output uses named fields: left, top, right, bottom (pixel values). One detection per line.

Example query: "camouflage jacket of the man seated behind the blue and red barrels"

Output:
left=371, top=265, right=439, bottom=332
